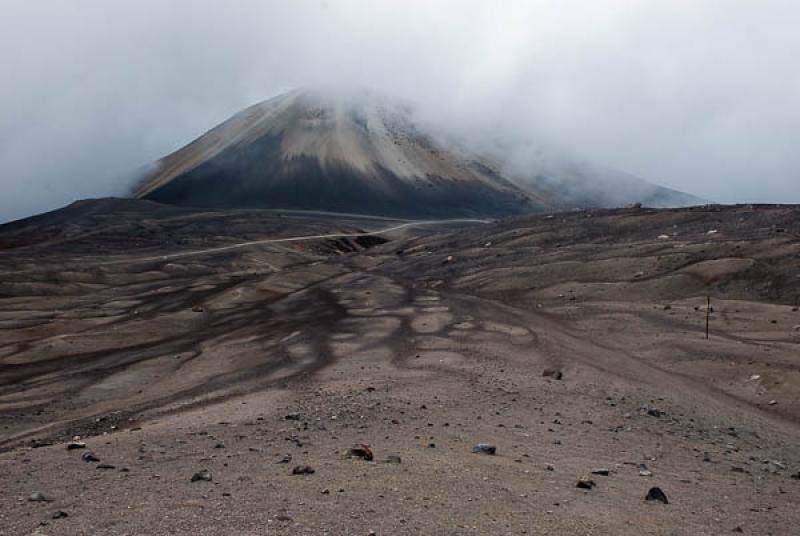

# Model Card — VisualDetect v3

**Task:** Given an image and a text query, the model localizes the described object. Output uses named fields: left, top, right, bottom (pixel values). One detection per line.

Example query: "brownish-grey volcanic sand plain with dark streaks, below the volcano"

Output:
left=0, top=202, right=800, bottom=535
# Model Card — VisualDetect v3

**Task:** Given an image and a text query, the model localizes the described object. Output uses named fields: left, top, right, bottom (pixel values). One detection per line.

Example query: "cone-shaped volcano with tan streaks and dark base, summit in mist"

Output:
left=133, top=90, right=701, bottom=218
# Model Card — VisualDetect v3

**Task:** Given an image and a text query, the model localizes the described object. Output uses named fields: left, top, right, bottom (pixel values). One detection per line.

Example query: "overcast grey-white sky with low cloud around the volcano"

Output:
left=0, top=0, right=800, bottom=221
